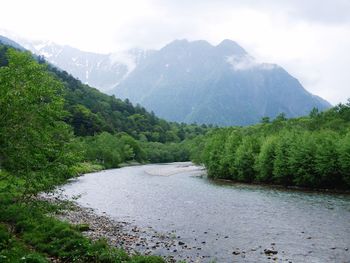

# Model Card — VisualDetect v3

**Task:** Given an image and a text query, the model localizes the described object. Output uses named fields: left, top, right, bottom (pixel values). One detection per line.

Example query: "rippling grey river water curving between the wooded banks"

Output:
left=63, top=163, right=350, bottom=263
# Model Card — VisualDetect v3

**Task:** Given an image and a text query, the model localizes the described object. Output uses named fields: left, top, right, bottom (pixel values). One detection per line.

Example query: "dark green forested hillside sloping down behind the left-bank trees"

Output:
left=0, top=36, right=207, bottom=143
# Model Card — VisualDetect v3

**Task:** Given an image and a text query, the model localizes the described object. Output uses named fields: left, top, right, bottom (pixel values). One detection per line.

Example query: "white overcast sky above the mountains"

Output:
left=0, top=0, right=350, bottom=104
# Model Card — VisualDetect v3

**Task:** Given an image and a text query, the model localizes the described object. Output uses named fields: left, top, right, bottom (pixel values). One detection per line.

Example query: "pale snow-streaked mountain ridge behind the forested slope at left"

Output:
left=16, top=38, right=151, bottom=92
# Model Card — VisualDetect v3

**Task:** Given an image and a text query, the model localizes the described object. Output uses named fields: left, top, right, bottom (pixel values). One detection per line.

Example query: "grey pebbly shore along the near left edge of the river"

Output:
left=40, top=195, right=208, bottom=263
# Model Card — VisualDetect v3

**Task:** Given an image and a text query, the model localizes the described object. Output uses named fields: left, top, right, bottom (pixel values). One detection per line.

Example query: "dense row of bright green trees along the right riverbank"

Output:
left=191, top=106, right=350, bottom=189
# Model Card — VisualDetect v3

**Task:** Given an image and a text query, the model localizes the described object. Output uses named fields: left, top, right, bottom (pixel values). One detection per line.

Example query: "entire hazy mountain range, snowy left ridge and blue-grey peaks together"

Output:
left=11, top=36, right=331, bottom=126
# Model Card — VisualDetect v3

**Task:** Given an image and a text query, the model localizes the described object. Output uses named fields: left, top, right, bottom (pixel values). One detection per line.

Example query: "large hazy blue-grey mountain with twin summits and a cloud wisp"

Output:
left=115, top=40, right=331, bottom=126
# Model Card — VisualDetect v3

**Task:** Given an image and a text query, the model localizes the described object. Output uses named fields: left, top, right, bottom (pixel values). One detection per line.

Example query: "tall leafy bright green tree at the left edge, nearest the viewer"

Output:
left=0, top=49, right=75, bottom=193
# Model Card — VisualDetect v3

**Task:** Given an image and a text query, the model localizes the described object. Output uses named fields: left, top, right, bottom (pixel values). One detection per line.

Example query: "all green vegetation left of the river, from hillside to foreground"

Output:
left=0, top=45, right=201, bottom=263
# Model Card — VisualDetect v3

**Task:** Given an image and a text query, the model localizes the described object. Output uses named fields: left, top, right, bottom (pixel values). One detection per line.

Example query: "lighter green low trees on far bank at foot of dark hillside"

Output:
left=71, top=132, right=189, bottom=168
